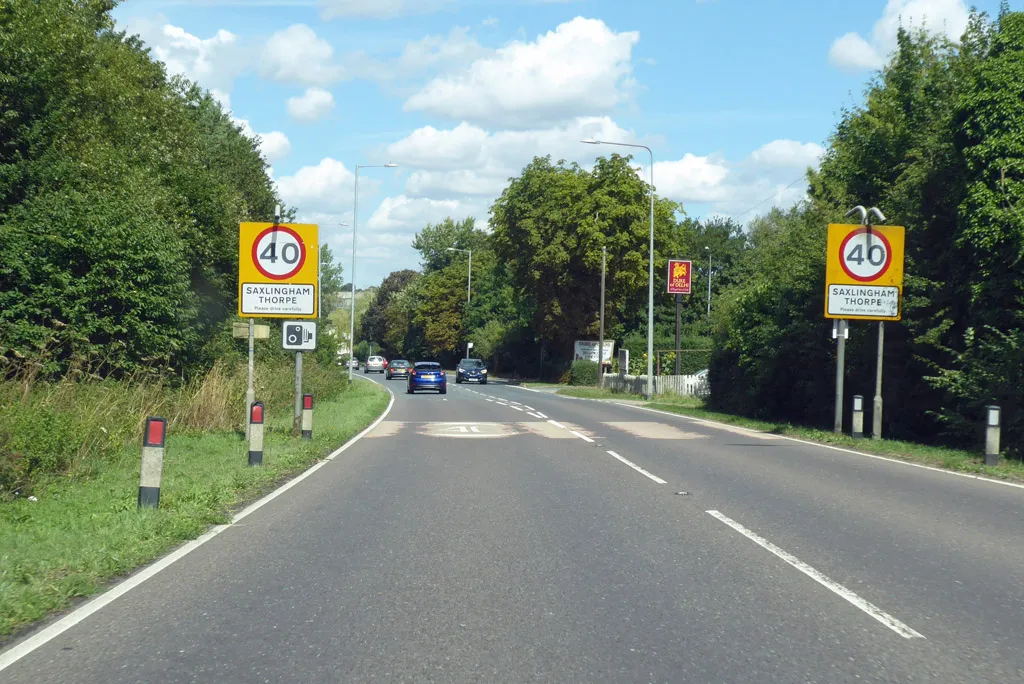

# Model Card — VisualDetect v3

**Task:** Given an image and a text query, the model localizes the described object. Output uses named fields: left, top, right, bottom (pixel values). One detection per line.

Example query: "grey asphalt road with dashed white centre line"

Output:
left=0, top=380, right=1024, bottom=684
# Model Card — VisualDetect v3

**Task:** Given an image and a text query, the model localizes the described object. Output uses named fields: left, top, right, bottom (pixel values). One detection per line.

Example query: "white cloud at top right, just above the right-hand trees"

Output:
left=828, top=0, right=970, bottom=72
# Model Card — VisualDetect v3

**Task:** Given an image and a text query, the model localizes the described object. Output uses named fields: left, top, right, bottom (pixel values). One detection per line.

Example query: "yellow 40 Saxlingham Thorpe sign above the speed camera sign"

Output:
left=239, top=223, right=319, bottom=318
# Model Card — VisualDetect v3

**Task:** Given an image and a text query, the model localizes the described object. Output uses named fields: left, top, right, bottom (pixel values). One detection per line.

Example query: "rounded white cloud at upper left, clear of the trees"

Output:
left=259, top=24, right=345, bottom=86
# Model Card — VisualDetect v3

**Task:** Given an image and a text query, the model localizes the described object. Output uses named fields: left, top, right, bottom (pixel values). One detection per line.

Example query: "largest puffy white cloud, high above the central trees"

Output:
left=404, top=16, right=640, bottom=128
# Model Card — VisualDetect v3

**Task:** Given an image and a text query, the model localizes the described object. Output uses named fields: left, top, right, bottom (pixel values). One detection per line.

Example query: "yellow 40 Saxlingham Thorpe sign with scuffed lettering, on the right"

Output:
left=825, top=223, right=905, bottom=320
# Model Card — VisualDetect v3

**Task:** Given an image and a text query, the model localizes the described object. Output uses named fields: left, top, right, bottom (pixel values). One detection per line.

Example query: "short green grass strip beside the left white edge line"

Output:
left=0, top=382, right=388, bottom=637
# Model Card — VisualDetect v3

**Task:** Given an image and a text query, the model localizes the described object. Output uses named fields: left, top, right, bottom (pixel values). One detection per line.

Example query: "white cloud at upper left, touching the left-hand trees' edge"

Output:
left=124, top=15, right=248, bottom=102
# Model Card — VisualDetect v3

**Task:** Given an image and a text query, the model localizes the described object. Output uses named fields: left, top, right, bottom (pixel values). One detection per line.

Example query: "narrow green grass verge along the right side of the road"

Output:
left=557, top=387, right=1024, bottom=482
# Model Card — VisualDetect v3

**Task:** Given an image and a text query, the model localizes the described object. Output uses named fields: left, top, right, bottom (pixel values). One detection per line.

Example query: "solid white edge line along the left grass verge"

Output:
left=0, top=376, right=394, bottom=672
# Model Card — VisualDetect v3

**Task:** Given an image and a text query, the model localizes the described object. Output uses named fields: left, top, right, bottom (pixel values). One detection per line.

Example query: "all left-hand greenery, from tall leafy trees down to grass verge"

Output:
left=0, top=0, right=387, bottom=637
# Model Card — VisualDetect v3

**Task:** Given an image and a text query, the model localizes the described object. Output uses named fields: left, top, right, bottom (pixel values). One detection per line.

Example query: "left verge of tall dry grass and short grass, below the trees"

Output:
left=0, top=362, right=388, bottom=638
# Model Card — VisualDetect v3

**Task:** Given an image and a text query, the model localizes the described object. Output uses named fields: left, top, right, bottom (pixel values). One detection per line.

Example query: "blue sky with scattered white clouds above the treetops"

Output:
left=114, top=0, right=999, bottom=289
